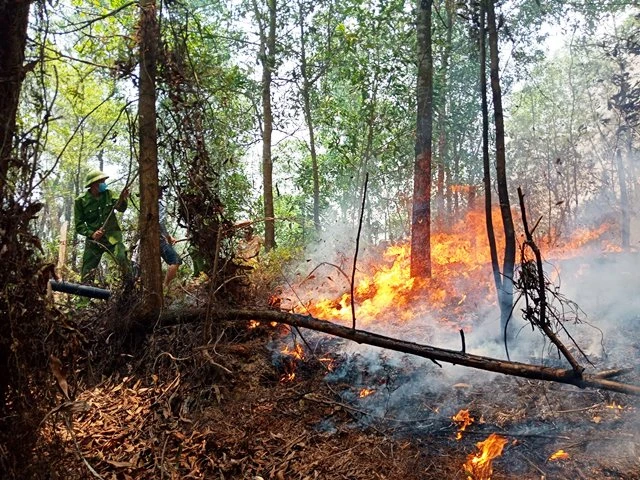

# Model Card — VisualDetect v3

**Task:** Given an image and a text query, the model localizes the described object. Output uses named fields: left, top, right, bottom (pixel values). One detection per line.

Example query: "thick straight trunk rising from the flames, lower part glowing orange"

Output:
left=411, top=0, right=433, bottom=278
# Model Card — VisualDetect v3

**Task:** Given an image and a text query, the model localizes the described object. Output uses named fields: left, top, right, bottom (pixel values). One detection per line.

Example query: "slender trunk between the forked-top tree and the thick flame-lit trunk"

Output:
left=299, top=1, right=321, bottom=234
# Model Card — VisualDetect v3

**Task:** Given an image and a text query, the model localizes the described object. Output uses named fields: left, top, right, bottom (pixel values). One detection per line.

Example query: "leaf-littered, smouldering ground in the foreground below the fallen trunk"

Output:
left=25, top=306, right=640, bottom=480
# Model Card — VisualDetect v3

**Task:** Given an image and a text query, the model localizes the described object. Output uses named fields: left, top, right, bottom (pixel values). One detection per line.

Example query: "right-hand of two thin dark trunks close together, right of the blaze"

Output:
left=487, top=0, right=516, bottom=331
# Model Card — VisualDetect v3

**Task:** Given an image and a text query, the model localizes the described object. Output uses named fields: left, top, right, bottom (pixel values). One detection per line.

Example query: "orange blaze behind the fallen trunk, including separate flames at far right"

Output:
left=291, top=205, right=612, bottom=328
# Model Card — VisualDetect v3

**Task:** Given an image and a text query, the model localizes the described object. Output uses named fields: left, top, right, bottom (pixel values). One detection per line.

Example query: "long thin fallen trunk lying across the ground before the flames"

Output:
left=160, top=309, right=640, bottom=395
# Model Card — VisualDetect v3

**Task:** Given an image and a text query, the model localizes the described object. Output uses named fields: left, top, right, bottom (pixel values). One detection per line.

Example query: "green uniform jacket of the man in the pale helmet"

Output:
left=74, top=190, right=127, bottom=245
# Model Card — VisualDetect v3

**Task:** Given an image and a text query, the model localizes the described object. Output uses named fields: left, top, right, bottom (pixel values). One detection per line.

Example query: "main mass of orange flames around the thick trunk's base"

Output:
left=295, top=212, right=498, bottom=324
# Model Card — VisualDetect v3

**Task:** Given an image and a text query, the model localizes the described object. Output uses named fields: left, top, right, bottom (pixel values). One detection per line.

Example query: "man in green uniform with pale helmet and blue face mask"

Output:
left=74, top=170, right=130, bottom=283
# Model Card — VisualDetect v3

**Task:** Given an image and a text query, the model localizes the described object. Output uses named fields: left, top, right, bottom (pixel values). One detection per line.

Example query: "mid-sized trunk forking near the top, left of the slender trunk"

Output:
left=253, top=0, right=277, bottom=251
